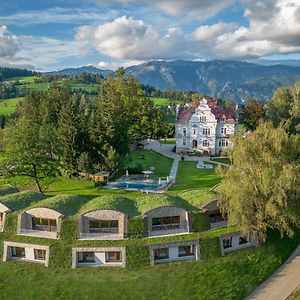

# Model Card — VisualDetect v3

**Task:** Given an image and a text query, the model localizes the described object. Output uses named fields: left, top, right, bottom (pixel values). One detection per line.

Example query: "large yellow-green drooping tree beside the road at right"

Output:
left=217, top=122, right=300, bottom=242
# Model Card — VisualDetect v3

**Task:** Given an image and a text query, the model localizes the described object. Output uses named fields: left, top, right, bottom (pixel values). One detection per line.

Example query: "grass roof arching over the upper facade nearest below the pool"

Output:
left=137, top=194, right=193, bottom=214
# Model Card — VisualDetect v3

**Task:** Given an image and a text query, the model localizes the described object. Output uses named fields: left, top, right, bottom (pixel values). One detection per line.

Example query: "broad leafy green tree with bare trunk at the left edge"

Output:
left=2, top=117, right=57, bottom=192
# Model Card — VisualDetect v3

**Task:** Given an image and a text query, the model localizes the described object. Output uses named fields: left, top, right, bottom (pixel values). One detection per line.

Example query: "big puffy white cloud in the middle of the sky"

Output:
left=76, top=16, right=184, bottom=60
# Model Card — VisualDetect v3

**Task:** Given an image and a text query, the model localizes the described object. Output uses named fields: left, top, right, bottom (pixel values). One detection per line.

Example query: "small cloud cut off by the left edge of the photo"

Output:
left=0, top=26, right=19, bottom=58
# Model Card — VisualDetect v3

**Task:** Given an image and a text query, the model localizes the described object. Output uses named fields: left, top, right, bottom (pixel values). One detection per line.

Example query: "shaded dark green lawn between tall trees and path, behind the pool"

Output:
left=123, top=150, right=173, bottom=177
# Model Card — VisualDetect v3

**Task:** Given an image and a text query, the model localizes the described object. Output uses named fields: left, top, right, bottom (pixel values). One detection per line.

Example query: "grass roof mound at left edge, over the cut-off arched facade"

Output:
left=0, top=191, right=46, bottom=211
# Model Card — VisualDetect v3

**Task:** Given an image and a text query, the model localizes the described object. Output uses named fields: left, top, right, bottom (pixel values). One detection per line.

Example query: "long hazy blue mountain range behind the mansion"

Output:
left=125, top=60, right=300, bottom=103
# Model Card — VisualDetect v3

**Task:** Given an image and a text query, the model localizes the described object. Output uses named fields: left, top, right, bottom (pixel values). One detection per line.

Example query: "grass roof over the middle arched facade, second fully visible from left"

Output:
left=79, top=195, right=137, bottom=216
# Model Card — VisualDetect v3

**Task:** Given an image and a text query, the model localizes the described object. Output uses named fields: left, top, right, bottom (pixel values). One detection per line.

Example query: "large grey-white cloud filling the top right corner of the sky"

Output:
left=192, top=0, right=300, bottom=59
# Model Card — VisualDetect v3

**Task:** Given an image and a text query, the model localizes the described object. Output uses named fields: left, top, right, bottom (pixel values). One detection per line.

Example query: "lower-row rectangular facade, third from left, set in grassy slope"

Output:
left=149, top=240, right=200, bottom=265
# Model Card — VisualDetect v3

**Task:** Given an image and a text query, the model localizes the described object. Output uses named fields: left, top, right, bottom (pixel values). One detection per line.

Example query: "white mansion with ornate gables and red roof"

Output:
left=175, top=97, right=237, bottom=155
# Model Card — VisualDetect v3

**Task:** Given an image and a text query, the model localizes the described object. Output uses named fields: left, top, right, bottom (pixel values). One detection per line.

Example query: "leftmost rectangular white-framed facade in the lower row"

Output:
left=3, top=241, right=49, bottom=267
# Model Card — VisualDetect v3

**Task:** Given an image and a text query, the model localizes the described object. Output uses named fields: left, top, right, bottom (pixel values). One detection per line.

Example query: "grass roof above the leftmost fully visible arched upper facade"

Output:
left=28, top=194, right=86, bottom=216
